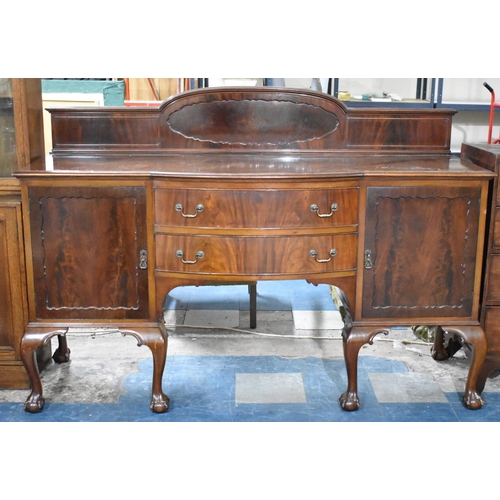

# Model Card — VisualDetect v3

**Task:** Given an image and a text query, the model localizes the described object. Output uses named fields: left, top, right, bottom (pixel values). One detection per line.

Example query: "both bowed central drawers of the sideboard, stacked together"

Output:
left=155, top=181, right=359, bottom=275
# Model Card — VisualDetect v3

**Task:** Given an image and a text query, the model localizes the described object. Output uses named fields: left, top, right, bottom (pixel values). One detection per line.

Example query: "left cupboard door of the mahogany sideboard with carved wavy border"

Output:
left=28, top=185, right=148, bottom=320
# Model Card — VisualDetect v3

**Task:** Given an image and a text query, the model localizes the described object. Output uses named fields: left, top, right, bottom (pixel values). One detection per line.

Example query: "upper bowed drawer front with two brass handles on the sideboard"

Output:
left=155, top=188, right=359, bottom=229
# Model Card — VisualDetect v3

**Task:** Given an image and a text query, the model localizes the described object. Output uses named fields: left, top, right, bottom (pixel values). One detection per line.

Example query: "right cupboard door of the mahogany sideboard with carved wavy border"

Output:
left=362, top=185, right=481, bottom=324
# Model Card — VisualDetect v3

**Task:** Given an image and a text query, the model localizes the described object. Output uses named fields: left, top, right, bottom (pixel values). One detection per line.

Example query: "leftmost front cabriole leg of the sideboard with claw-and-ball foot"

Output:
left=21, top=329, right=67, bottom=413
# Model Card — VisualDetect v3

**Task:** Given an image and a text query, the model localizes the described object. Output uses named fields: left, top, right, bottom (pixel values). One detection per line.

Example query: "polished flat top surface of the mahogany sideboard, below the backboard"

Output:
left=16, top=154, right=493, bottom=180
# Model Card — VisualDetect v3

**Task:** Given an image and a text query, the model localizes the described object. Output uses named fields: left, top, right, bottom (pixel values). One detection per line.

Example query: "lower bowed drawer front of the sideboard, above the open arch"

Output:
left=156, top=234, right=357, bottom=275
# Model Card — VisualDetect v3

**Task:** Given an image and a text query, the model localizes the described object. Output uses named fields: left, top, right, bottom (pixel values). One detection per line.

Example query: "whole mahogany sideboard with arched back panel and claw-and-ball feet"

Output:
left=16, top=87, right=495, bottom=412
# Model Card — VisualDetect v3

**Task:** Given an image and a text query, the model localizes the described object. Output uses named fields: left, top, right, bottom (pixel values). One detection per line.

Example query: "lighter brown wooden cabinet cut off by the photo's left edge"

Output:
left=0, top=78, right=50, bottom=389
